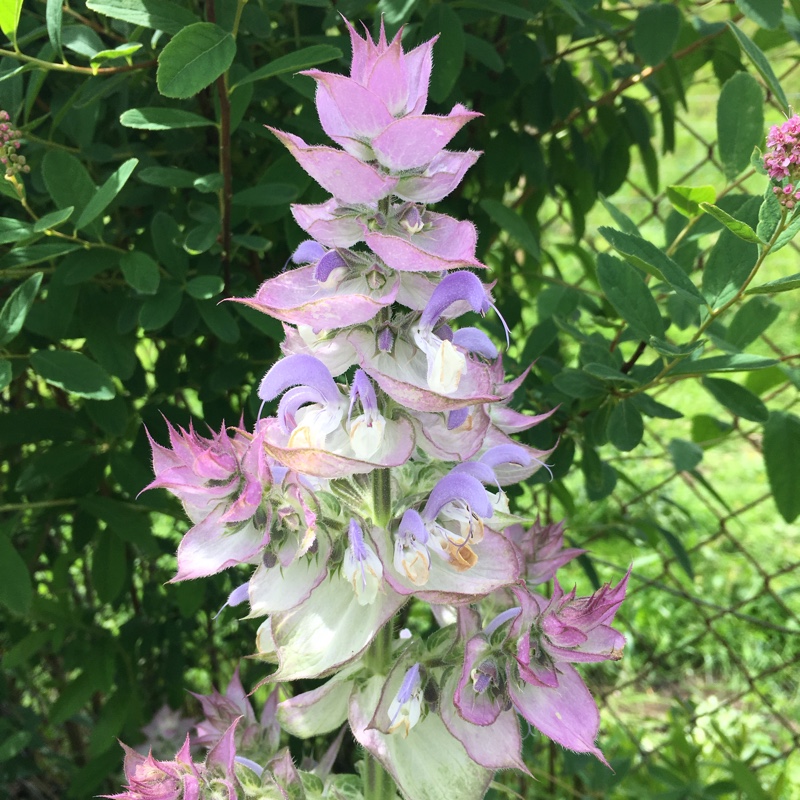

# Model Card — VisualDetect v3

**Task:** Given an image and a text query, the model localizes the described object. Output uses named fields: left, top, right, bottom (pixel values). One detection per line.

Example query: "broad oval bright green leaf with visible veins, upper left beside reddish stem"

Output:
left=156, top=22, right=236, bottom=100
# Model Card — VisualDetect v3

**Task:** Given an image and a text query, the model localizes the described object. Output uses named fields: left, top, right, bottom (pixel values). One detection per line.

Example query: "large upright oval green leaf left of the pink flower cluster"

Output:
left=717, top=72, right=764, bottom=180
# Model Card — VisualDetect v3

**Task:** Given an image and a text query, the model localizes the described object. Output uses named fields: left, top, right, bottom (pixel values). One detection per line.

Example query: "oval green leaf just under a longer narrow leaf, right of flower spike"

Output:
left=597, top=253, right=664, bottom=341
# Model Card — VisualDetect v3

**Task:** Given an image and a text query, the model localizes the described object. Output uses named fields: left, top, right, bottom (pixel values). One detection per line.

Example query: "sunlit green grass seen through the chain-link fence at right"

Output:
left=517, top=53, right=800, bottom=799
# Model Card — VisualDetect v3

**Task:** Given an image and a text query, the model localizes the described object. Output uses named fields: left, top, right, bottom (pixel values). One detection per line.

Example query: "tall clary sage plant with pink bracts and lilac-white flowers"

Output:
left=114, top=24, right=627, bottom=800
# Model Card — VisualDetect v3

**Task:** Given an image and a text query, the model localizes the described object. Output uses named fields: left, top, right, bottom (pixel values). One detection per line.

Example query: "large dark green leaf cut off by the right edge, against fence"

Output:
left=764, top=411, right=800, bottom=523
